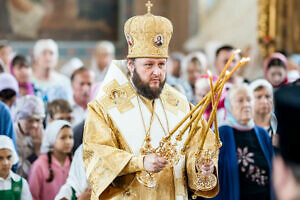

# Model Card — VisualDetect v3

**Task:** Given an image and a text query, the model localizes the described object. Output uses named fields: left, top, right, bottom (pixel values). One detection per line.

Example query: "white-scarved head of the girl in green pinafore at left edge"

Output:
left=0, top=135, right=19, bottom=179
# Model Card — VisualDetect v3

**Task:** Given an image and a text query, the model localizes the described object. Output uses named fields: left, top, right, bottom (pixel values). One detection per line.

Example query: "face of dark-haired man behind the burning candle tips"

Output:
left=215, top=50, right=240, bottom=75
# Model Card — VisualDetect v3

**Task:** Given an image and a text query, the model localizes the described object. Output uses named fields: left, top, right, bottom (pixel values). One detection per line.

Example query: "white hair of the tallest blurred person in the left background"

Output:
left=33, top=39, right=58, bottom=59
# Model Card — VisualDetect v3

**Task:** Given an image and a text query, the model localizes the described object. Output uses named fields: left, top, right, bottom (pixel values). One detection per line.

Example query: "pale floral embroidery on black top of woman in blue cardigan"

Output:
left=237, top=147, right=268, bottom=186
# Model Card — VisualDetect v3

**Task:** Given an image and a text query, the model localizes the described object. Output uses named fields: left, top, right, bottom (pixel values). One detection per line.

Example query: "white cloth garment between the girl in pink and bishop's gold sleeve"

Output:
left=67, top=145, right=89, bottom=195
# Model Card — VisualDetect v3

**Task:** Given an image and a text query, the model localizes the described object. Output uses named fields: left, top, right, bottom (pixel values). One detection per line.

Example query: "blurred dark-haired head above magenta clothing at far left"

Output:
left=11, top=55, right=32, bottom=83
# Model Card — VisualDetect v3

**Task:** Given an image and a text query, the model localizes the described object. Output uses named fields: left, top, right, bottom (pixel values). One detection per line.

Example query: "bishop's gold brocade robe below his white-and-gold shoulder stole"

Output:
left=83, top=100, right=219, bottom=200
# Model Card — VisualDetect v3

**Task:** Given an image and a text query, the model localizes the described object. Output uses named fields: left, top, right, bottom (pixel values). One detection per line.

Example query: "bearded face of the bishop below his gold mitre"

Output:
left=127, top=58, right=167, bottom=99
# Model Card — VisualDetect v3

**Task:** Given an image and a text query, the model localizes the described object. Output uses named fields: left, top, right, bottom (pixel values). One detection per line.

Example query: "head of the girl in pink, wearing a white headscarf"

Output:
left=41, top=120, right=74, bottom=154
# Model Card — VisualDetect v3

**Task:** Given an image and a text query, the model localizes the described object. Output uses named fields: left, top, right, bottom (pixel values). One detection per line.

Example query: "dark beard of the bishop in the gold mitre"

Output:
left=132, top=69, right=166, bottom=100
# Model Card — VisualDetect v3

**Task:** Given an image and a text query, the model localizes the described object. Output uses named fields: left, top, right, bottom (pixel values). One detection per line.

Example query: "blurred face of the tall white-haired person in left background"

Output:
left=36, top=50, right=57, bottom=69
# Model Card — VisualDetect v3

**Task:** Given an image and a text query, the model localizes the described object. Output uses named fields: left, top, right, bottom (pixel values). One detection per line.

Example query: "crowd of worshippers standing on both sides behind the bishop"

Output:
left=0, top=36, right=300, bottom=200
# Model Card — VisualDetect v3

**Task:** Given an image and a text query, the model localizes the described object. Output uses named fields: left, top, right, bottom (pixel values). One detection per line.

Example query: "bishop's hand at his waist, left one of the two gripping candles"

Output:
left=144, top=153, right=168, bottom=173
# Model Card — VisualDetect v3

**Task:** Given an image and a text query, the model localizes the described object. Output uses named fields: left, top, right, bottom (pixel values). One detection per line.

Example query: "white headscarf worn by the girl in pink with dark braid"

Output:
left=41, top=120, right=71, bottom=153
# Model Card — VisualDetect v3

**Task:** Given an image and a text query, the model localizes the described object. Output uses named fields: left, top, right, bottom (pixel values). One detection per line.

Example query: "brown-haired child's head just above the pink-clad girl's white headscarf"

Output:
left=48, top=99, right=73, bottom=123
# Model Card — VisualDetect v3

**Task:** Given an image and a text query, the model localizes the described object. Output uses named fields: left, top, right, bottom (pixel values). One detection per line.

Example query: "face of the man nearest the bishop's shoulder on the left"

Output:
left=72, top=71, right=95, bottom=104
